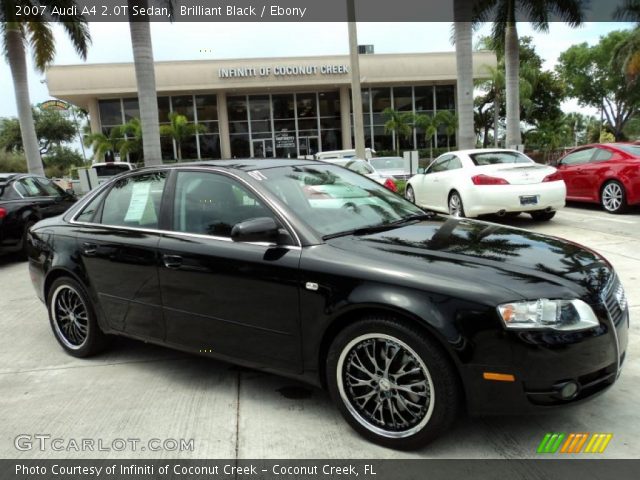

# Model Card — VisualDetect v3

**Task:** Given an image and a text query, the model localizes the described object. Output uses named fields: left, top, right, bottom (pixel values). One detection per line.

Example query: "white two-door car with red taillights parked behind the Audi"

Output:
left=405, top=149, right=566, bottom=221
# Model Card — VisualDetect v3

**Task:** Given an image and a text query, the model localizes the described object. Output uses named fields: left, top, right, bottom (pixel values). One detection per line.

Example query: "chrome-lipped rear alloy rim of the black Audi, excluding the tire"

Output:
left=51, top=285, right=89, bottom=350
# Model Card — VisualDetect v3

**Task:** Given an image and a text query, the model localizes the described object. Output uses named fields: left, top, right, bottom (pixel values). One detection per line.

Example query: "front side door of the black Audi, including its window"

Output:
left=159, top=171, right=301, bottom=372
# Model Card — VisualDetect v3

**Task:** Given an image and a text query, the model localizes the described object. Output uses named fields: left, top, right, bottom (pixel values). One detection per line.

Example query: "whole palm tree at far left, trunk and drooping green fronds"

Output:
left=0, top=0, right=91, bottom=175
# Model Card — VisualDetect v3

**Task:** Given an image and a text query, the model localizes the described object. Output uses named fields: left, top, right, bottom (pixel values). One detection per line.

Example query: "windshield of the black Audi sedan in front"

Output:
left=250, top=165, right=424, bottom=236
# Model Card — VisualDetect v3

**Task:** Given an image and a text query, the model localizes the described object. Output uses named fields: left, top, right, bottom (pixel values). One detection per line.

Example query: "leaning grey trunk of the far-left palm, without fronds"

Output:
left=5, top=26, right=44, bottom=175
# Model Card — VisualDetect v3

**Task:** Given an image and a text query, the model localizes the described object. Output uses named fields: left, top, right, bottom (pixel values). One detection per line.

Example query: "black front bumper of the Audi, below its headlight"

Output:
left=462, top=290, right=629, bottom=415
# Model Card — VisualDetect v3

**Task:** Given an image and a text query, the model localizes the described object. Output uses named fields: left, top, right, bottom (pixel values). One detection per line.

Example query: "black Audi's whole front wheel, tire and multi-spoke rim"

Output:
left=327, top=316, right=462, bottom=450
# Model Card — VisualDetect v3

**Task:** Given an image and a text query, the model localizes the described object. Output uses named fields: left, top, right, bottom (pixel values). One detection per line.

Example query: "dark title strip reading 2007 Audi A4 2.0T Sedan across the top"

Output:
left=0, top=0, right=640, bottom=22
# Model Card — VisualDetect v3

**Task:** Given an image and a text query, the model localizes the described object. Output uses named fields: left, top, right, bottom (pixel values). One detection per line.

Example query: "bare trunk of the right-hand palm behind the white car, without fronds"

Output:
left=504, top=22, right=522, bottom=148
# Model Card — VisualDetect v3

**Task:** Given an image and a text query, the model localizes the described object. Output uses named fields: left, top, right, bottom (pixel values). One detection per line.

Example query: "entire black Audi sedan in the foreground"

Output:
left=29, top=159, right=629, bottom=449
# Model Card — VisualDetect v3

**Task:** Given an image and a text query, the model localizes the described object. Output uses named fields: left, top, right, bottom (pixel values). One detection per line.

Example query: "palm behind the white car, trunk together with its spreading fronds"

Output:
left=476, top=0, right=584, bottom=146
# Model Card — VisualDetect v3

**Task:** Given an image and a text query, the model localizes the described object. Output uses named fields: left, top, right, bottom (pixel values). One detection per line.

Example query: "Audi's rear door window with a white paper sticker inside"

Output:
left=99, top=172, right=167, bottom=228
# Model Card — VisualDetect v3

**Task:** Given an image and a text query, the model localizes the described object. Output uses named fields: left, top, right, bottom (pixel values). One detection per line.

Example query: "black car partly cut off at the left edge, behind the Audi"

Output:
left=0, top=173, right=76, bottom=254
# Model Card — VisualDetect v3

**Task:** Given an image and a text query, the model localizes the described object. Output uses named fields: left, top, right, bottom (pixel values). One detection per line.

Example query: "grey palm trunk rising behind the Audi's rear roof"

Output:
left=128, top=4, right=162, bottom=166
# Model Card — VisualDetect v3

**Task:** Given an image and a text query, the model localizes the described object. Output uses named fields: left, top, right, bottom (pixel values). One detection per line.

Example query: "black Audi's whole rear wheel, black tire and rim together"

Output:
left=47, top=277, right=107, bottom=358
